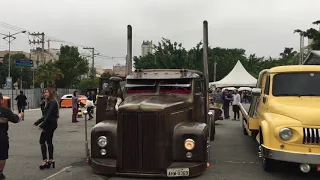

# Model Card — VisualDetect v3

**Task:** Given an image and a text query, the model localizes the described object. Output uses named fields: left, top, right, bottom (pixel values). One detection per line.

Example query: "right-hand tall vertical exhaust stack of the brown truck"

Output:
left=203, top=21, right=209, bottom=122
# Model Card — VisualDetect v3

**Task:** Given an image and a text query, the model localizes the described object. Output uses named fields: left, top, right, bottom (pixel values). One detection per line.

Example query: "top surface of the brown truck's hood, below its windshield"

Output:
left=119, top=95, right=188, bottom=111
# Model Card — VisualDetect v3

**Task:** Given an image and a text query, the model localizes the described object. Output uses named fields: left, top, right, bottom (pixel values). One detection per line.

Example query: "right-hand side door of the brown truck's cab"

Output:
left=194, top=79, right=205, bottom=122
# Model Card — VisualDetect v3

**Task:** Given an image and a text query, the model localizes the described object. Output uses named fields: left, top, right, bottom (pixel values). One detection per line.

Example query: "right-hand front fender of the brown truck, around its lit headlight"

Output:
left=172, top=122, right=209, bottom=161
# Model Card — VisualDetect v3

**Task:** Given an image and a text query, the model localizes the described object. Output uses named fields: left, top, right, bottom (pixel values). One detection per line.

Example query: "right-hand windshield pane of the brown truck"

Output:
left=159, top=79, right=191, bottom=94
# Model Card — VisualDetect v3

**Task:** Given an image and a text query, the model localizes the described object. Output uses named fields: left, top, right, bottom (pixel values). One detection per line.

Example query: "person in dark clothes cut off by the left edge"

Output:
left=0, top=92, right=24, bottom=179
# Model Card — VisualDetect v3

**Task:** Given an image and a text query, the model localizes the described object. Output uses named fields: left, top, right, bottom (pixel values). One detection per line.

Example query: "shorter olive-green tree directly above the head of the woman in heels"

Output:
left=35, top=61, right=65, bottom=87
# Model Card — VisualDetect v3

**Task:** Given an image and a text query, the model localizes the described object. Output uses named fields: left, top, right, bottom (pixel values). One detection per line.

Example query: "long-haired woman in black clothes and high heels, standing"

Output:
left=34, top=88, right=59, bottom=170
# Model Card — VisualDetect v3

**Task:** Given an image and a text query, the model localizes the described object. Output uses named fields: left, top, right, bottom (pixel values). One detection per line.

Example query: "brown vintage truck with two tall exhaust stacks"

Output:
left=86, top=21, right=215, bottom=177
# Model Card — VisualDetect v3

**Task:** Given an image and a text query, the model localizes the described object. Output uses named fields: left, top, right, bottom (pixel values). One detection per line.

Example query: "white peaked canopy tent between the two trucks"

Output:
left=209, top=61, right=257, bottom=87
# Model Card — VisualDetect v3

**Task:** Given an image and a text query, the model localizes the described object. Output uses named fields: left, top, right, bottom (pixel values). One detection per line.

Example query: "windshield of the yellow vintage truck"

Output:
left=272, top=72, right=320, bottom=96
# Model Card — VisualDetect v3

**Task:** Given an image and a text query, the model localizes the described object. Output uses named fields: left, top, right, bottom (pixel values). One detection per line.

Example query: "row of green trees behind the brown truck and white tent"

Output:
left=133, top=38, right=298, bottom=81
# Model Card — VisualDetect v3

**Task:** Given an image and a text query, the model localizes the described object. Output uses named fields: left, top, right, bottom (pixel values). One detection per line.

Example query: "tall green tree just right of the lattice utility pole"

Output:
left=54, top=46, right=89, bottom=88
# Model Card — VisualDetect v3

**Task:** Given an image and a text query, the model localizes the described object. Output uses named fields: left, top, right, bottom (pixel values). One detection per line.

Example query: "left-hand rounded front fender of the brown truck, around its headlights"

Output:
left=91, top=120, right=117, bottom=158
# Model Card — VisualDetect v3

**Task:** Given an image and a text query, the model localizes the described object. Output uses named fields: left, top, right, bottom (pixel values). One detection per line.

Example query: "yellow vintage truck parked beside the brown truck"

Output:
left=241, top=65, right=320, bottom=173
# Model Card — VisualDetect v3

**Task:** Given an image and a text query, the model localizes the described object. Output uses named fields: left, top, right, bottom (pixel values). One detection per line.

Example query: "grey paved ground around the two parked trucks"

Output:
left=5, top=105, right=320, bottom=180
